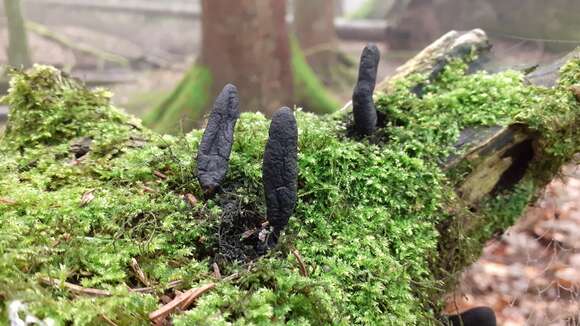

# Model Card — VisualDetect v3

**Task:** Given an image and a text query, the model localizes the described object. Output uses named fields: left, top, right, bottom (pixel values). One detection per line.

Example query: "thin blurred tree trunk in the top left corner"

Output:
left=4, top=0, right=32, bottom=68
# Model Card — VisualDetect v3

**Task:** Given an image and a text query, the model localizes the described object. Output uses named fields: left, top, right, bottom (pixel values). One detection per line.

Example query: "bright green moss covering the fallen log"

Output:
left=0, top=60, right=580, bottom=325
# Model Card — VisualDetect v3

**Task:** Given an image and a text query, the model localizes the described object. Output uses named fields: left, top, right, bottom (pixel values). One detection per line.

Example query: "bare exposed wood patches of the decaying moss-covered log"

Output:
left=377, top=29, right=578, bottom=207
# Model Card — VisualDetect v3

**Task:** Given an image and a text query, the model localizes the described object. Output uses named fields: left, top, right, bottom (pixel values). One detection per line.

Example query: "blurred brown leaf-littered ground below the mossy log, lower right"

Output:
left=447, top=165, right=580, bottom=326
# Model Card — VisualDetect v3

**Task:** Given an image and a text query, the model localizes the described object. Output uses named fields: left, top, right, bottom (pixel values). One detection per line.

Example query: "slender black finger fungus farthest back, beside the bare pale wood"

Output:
left=352, top=44, right=381, bottom=136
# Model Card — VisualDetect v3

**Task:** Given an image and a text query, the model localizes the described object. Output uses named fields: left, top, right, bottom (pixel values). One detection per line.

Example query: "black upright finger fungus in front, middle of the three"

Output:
left=262, top=107, right=298, bottom=247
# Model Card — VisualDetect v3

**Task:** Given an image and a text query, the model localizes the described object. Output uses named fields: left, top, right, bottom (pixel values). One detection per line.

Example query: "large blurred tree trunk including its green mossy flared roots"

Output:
left=145, top=0, right=339, bottom=132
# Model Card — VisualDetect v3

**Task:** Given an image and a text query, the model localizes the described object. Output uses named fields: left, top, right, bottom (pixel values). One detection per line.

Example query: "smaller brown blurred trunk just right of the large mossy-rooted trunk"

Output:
left=294, top=0, right=338, bottom=81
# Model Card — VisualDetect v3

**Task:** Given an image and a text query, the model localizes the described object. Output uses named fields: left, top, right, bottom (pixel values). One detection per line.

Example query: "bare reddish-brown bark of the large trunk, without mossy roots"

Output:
left=200, top=0, right=292, bottom=114
